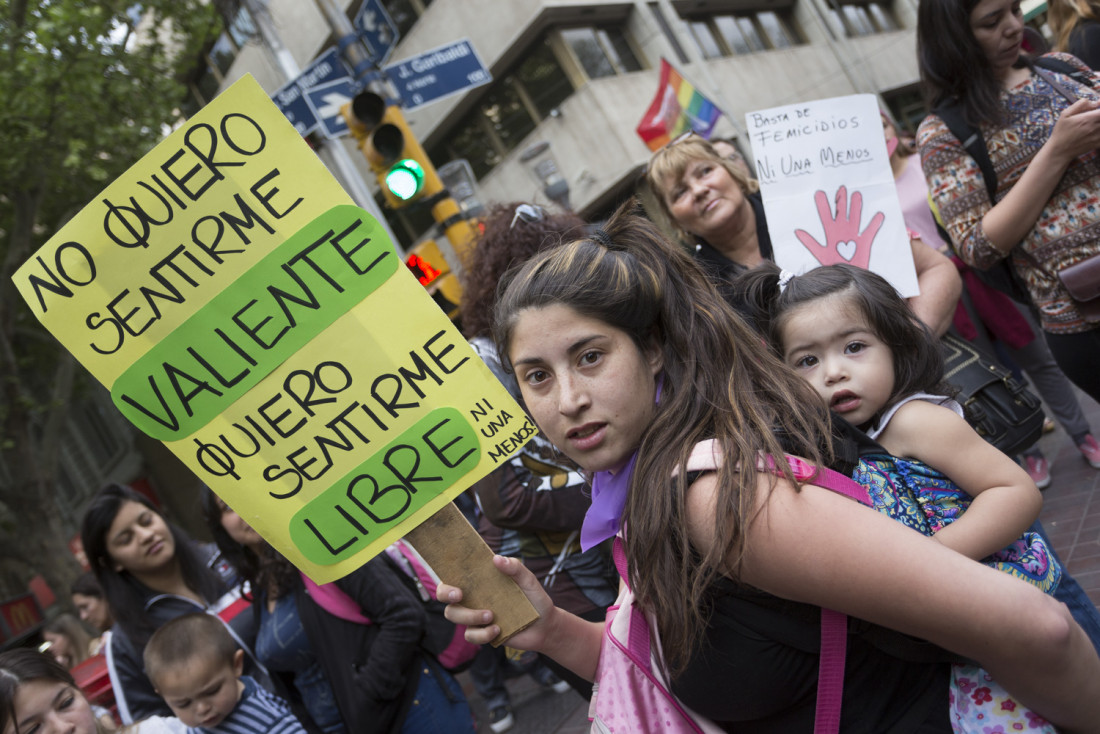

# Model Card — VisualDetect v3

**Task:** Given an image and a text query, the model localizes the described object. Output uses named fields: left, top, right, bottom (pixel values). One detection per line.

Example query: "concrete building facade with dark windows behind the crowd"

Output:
left=202, top=0, right=923, bottom=245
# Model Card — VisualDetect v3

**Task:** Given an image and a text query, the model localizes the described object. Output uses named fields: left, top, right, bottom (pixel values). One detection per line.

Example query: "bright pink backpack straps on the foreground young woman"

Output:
left=673, top=439, right=871, bottom=734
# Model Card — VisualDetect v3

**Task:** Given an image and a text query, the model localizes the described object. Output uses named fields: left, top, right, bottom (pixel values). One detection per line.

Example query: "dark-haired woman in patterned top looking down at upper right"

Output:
left=917, top=0, right=1100, bottom=401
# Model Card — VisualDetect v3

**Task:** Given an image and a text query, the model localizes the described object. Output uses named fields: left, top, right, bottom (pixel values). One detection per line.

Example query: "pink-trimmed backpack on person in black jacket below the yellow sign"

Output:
left=301, top=540, right=481, bottom=672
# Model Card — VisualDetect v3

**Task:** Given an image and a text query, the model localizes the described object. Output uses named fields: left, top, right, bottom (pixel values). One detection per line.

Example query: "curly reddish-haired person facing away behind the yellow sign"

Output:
left=462, top=201, right=618, bottom=732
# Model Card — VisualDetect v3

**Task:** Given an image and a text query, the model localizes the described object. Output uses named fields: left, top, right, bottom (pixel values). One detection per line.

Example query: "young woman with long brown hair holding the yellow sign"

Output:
left=439, top=203, right=1100, bottom=732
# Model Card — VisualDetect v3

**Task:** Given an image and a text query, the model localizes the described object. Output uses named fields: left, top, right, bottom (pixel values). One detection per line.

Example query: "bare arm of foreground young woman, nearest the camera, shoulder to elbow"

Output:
left=688, top=473, right=1100, bottom=732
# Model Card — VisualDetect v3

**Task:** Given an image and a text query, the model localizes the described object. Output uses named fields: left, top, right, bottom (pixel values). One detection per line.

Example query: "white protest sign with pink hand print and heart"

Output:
left=745, top=95, right=920, bottom=297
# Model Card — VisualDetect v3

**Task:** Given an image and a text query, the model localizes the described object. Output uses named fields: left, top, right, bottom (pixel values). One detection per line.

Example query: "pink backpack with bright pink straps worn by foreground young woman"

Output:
left=589, top=440, right=870, bottom=734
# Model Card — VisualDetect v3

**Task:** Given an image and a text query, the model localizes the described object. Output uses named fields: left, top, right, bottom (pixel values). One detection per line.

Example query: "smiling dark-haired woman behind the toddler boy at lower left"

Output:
left=80, top=484, right=261, bottom=724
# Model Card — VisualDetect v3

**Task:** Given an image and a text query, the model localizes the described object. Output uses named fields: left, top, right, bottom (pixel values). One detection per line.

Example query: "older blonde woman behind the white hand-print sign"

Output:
left=646, top=133, right=961, bottom=333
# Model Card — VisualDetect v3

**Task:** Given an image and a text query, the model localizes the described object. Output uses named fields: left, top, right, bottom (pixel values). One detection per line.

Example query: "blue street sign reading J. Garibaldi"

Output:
left=382, top=39, right=493, bottom=110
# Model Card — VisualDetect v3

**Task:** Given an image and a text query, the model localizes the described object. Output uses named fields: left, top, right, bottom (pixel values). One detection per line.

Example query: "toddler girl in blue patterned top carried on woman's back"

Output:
left=739, top=263, right=1063, bottom=734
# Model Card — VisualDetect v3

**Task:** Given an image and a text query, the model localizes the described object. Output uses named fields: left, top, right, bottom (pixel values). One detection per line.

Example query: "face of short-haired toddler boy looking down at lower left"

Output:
left=156, top=650, right=244, bottom=728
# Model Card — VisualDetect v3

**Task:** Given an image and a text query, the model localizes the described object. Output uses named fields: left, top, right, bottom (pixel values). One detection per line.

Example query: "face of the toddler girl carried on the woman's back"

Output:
left=782, top=295, right=894, bottom=426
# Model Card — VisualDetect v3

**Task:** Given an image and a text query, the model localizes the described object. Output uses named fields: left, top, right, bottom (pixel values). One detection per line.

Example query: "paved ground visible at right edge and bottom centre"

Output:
left=459, top=392, right=1100, bottom=734
